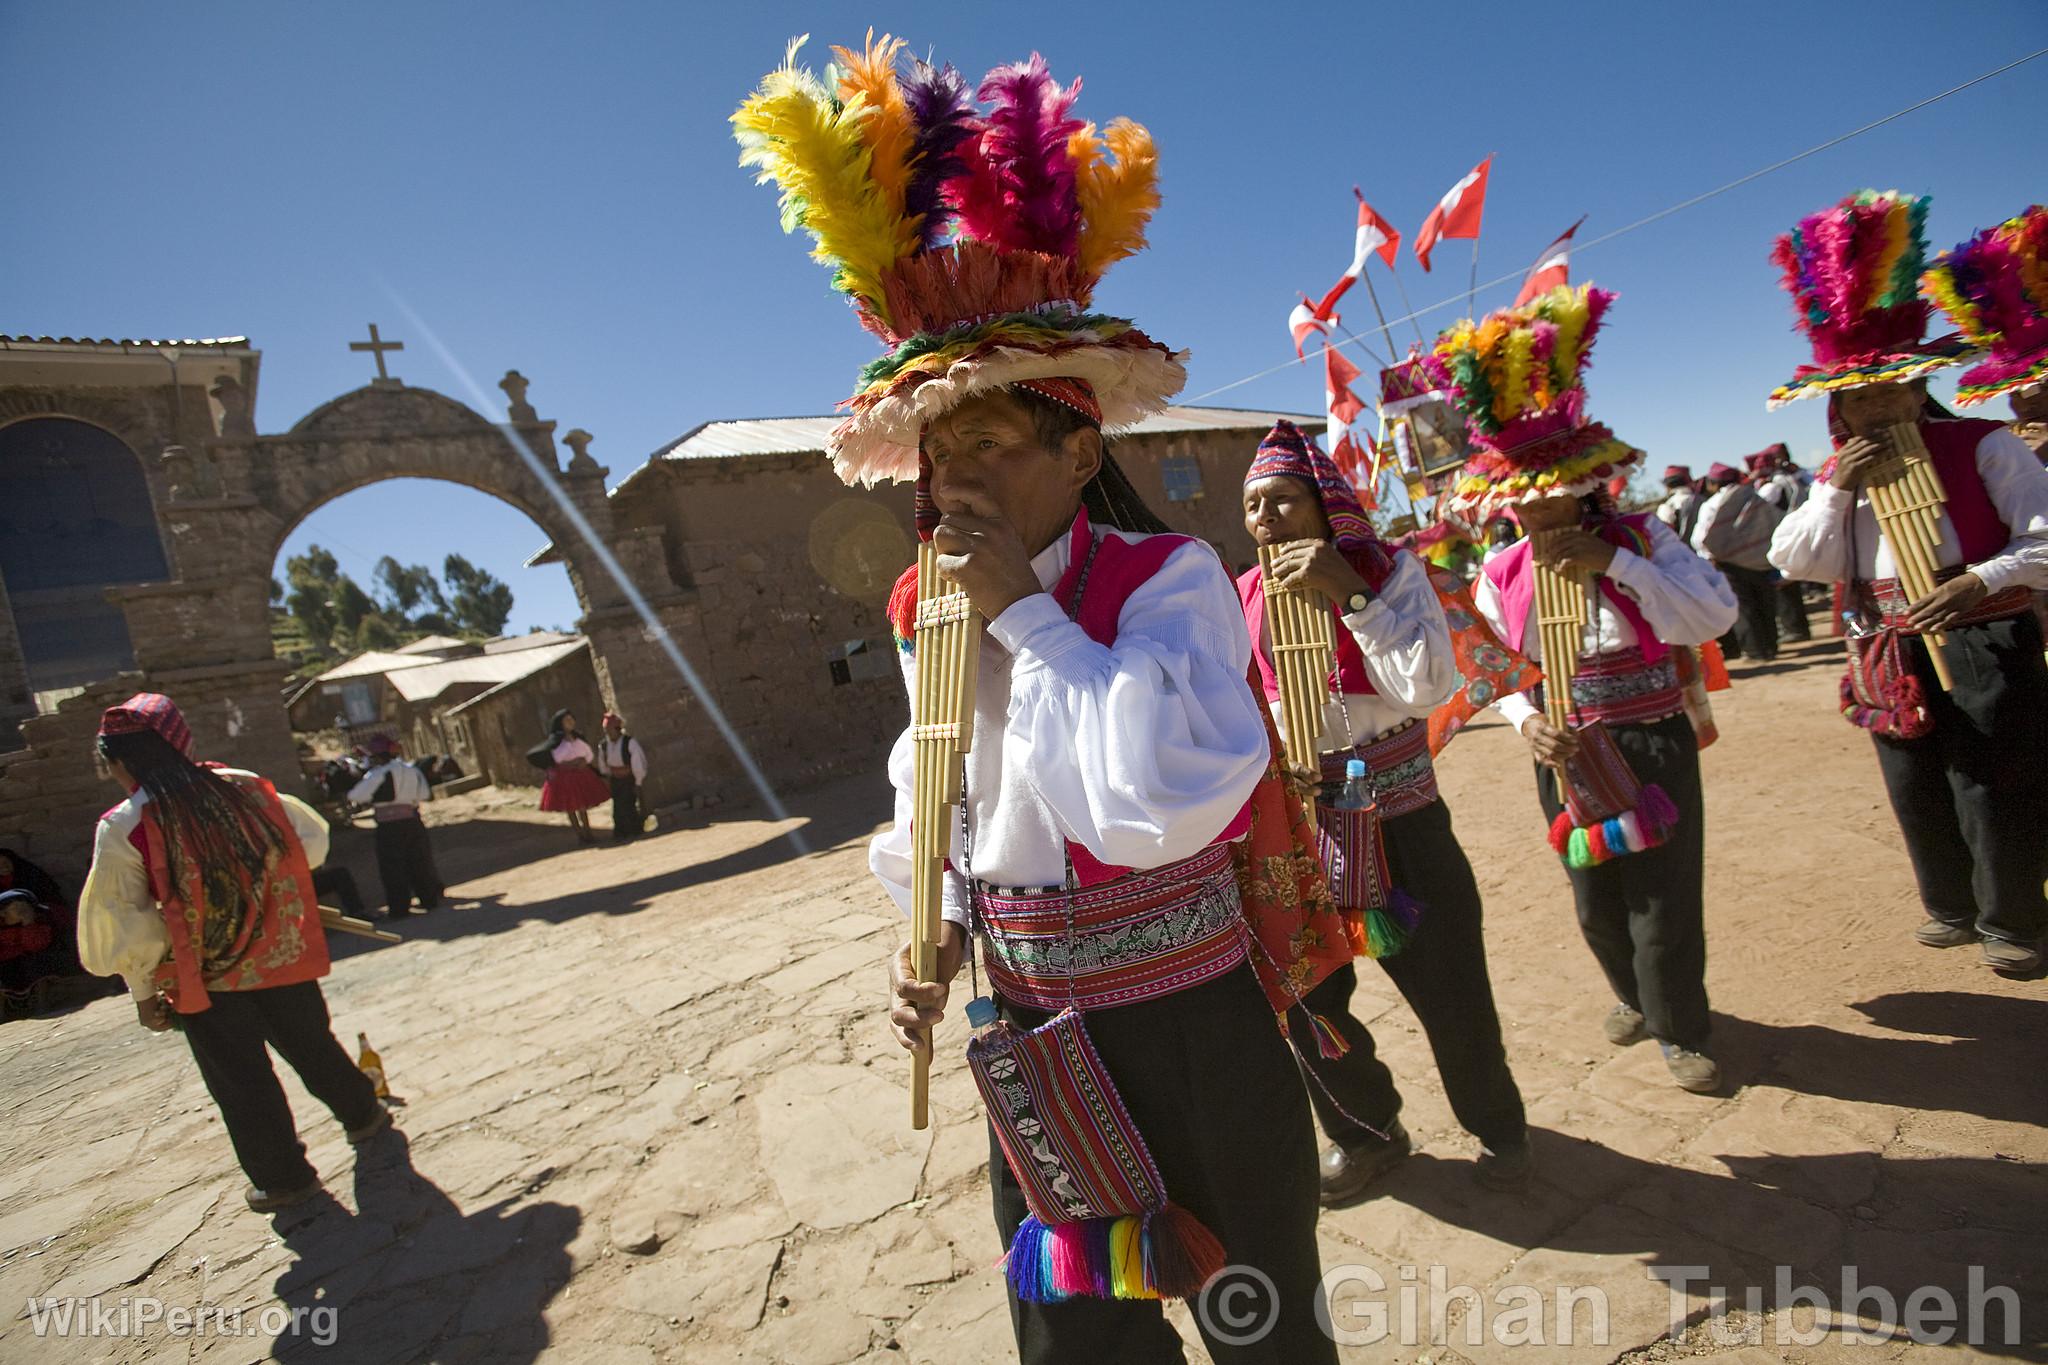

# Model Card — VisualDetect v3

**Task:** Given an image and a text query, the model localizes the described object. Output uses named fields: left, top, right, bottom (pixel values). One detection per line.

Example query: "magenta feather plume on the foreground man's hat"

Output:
left=952, top=53, right=1081, bottom=256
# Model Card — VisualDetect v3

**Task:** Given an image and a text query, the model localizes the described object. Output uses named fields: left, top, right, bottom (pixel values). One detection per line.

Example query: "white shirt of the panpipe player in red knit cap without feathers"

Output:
left=1262, top=551, right=1458, bottom=753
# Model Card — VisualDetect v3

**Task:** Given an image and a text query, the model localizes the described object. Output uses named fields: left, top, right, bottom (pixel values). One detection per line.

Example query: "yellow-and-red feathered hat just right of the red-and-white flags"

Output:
left=1423, top=284, right=1642, bottom=524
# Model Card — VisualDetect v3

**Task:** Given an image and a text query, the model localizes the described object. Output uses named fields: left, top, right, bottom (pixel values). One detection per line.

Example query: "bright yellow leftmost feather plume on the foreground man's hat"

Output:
left=731, top=39, right=915, bottom=325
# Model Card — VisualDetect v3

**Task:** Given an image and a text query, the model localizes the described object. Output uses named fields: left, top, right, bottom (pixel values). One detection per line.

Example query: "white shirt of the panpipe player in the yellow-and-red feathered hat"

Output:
left=1473, top=520, right=1737, bottom=733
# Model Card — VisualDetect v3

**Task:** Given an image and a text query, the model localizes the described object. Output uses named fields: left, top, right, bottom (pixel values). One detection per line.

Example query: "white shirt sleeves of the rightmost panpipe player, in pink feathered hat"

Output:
left=1772, top=428, right=2048, bottom=591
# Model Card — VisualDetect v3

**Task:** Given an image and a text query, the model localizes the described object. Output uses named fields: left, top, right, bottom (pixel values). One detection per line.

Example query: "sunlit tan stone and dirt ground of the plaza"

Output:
left=0, top=645, right=2048, bottom=1365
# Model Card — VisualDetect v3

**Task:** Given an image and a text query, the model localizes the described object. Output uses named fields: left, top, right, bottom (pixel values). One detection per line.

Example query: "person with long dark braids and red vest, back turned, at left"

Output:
left=78, top=692, right=391, bottom=1214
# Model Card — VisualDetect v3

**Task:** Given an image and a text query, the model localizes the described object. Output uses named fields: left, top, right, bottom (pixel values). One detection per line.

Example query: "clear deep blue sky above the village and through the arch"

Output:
left=0, top=0, right=2048, bottom=628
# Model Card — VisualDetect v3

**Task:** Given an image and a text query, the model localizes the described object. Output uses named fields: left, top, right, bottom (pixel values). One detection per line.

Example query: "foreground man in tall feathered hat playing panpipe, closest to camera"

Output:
left=733, top=37, right=1341, bottom=1365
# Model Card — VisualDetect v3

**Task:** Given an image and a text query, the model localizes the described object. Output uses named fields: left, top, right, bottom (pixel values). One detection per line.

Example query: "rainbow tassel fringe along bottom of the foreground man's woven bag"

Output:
left=1004, top=1203, right=1225, bottom=1304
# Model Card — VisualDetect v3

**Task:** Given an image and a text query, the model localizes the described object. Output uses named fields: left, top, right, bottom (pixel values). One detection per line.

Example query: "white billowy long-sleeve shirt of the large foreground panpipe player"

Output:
left=868, top=530, right=1270, bottom=925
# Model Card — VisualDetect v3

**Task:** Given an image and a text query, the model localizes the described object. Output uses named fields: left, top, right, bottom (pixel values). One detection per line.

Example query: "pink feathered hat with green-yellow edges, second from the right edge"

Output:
left=1769, top=190, right=1970, bottom=407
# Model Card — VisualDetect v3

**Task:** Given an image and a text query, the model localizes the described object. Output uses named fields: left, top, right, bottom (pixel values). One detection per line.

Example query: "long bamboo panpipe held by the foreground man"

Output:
left=909, top=540, right=981, bottom=1130
